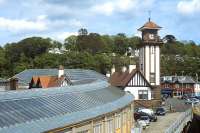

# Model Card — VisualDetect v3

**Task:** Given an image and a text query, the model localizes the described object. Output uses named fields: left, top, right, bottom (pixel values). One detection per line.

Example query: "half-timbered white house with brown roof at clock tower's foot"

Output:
left=110, top=65, right=154, bottom=100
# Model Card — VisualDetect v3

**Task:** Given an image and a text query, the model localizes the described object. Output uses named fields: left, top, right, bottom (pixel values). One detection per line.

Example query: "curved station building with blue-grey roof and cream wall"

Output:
left=0, top=69, right=134, bottom=133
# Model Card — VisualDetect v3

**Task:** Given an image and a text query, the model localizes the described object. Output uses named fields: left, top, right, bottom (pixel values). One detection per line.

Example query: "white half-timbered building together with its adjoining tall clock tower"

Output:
left=110, top=19, right=162, bottom=100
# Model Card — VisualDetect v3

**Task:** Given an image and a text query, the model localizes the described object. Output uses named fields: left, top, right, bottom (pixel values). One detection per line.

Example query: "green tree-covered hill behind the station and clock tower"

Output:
left=0, top=29, right=200, bottom=78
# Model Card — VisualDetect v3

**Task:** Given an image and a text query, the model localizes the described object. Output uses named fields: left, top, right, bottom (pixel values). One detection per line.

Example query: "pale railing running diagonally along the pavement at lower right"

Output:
left=165, top=108, right=192, bottom=133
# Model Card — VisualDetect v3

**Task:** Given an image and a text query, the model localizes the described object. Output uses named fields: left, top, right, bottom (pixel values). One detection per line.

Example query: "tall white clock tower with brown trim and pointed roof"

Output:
left=138, top=18, right=163, bottom=86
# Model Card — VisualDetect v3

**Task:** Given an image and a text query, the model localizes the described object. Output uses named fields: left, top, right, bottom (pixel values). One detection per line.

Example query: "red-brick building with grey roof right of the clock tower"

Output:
left=161, top=76, right=195, bottom=96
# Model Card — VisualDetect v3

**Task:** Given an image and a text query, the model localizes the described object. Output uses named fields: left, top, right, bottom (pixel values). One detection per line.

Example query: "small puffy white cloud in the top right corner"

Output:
left=177, top=0, right=200, bottom=14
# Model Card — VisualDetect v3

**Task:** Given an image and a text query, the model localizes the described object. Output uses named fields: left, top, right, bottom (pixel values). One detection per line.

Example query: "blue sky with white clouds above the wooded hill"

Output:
left=0, top=0, right=200, bottom=45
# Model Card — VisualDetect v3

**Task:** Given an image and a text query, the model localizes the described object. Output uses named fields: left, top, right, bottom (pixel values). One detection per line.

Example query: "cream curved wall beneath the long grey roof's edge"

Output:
left=46, top=103, right=133, bottom=133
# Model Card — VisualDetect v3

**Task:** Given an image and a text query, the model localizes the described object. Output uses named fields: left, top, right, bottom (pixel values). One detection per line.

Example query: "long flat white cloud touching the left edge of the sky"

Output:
left=0, top=16, right=47, bottom=32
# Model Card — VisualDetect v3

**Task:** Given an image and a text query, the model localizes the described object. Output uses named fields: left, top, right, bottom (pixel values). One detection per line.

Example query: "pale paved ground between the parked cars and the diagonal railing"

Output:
left=142, top=112, right=181, bottom=133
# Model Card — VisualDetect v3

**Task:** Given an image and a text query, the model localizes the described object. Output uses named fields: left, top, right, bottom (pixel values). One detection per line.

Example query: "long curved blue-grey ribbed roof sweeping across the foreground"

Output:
left=0, top=70, right=133, bottom=133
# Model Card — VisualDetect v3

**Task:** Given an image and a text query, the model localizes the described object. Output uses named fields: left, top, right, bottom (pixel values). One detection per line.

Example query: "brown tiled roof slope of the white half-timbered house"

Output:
left=109, top=69, right=137, bottom=87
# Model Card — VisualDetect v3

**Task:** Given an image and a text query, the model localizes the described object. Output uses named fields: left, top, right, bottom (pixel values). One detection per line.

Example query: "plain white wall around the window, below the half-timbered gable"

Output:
left=124, top=87, right=152, bottom=100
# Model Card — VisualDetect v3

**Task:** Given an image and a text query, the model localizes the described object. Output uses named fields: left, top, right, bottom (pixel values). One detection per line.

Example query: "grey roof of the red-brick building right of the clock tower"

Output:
left=161, top=76, right=195, bottom=84
